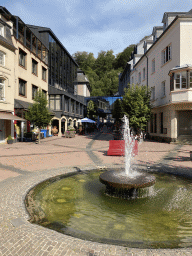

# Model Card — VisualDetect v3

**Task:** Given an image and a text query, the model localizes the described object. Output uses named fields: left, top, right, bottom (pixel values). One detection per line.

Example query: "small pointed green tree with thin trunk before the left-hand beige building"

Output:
left=25, top=90, right=52, bottom=143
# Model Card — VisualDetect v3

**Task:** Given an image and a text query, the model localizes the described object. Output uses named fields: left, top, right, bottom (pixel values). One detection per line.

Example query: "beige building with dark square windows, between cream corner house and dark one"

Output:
left=13, top=19, right=48, bottom=140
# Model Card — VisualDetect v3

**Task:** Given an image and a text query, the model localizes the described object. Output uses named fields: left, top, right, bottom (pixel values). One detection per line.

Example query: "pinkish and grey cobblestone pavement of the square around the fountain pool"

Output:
left=0, top=132, right=192, bottom=256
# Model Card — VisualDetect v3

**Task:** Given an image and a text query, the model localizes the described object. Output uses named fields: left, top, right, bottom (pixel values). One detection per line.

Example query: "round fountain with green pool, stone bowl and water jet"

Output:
left=25, top=114, right=192, bottom=249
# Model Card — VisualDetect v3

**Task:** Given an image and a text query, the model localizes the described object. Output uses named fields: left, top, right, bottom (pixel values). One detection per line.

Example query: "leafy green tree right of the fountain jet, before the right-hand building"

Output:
left=123, top=85, right=151, bottom=130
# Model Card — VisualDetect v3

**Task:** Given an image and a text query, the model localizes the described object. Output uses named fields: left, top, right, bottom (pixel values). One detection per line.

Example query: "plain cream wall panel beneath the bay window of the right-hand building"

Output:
left=171, top=89, right=192, bottom=103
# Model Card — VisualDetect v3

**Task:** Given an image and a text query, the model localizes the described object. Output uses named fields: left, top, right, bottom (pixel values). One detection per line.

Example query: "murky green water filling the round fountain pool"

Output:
left=28, top=171, right=192, bottom=248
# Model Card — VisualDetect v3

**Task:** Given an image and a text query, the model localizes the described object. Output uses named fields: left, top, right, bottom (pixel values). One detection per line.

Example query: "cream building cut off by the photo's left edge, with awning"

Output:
left=0, top=10, right=22, bottom=143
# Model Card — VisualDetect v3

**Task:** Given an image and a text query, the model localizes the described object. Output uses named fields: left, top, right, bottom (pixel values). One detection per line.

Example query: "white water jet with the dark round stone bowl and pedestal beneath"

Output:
left=99, top=115, right=155, bottom=198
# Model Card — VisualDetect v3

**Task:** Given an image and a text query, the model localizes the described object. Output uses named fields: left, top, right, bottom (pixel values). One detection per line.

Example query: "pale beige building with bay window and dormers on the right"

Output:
left=128, top=11, right=192, bottom=141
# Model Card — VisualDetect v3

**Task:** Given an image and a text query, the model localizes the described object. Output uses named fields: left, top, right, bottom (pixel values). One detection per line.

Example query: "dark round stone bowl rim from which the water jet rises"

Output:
left=99, top=170, right=156, bottom=190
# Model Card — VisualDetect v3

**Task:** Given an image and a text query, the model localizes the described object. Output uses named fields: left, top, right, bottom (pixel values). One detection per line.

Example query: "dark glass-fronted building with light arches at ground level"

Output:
left=28, top=25, right=86, bottom=136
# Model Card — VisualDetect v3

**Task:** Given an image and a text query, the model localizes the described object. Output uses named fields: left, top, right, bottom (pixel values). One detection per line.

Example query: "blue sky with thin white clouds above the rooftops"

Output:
left=0, top=0, right=192, bottom=58
